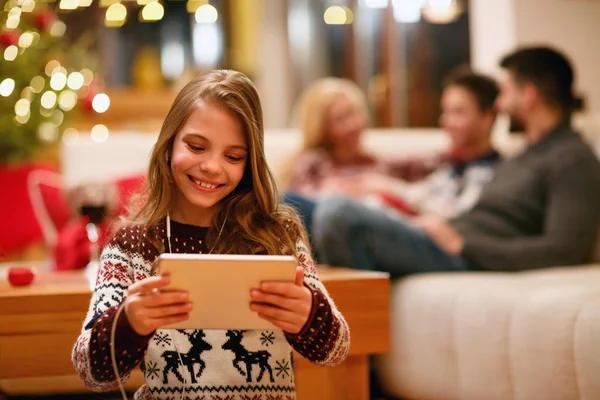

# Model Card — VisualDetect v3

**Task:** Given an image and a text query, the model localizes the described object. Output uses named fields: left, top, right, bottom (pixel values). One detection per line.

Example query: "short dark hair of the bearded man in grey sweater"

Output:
left=500, top=47, right=583, bottom=114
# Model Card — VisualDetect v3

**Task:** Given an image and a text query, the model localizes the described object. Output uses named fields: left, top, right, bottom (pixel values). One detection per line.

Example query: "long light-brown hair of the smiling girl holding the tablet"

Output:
left=127, top=70, right=307, bottom=254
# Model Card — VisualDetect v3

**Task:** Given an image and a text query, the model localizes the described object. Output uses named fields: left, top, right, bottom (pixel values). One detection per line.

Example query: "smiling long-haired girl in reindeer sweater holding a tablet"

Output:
left=73, top=71, right=350, bottom=400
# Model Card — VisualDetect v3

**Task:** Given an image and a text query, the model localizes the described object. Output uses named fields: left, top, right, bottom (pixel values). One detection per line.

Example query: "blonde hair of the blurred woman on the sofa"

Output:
left=280, top=77, right=369, bottom=187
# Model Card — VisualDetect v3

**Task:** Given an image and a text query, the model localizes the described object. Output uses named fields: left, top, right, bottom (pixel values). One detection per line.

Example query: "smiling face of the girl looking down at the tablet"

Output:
left=170, top=103, right=248, bottom=226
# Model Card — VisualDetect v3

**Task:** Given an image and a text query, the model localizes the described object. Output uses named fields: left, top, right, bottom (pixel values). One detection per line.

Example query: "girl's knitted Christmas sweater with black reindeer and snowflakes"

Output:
left=73, top=221, right=350, bottom=400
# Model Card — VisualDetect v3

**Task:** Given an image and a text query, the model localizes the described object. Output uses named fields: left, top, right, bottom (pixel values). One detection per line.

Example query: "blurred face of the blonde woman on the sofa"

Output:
left=326, top=95, right=367, bottom=151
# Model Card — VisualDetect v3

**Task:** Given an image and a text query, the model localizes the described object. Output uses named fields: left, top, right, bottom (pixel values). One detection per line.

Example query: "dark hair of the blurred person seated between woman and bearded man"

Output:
left=444, top=67, right=499, bottom=111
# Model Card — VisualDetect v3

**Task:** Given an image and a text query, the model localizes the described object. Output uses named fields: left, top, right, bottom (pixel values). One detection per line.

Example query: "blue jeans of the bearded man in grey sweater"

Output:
left=313, top=197, right=467, bottom=278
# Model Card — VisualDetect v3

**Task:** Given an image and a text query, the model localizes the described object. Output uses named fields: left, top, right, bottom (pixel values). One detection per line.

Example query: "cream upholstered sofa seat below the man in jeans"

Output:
left=377, top=266, right=600, bottom=400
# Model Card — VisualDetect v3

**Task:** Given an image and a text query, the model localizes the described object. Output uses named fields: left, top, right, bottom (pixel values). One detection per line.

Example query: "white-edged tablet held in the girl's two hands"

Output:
left=158, top=253, right=298, bottom=329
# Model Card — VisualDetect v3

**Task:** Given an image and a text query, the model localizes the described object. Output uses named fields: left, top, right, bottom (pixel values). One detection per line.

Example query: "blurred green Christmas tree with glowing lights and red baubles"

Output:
left=0, top=0, right=104, bottom=164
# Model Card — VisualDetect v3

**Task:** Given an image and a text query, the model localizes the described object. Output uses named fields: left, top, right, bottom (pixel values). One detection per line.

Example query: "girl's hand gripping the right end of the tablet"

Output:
left=250, top=267, right=312, bottom=334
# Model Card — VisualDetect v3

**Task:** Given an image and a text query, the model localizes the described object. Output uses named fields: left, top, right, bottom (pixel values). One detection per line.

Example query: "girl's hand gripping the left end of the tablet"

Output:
left=125, top=276, right=192, bottom=336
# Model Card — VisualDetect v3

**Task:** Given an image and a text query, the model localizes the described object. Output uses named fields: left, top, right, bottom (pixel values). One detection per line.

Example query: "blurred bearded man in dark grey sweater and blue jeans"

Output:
left=313, top=47, right=600, bottom=277
